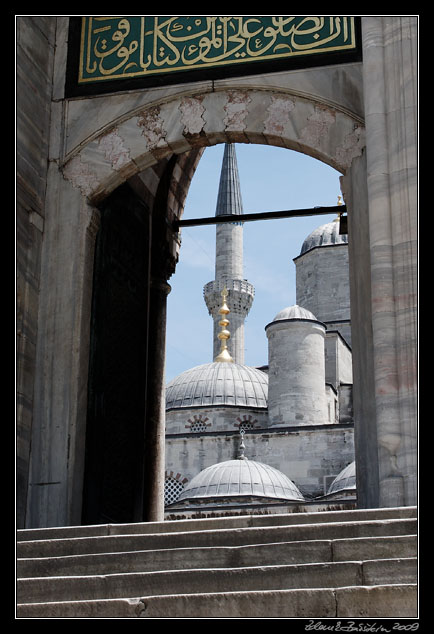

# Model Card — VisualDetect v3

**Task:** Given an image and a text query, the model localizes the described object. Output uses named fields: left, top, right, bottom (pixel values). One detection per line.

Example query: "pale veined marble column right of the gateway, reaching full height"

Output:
left=362, top=16, right=417, bottom=506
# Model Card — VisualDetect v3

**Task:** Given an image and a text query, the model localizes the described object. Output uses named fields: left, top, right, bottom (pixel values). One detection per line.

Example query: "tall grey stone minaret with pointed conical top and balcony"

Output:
left=203, top=143, right=254, bottom=365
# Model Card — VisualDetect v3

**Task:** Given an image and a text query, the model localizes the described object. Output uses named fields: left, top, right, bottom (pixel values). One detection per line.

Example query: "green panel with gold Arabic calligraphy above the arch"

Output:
left=78, top=16, right=356, bottom=84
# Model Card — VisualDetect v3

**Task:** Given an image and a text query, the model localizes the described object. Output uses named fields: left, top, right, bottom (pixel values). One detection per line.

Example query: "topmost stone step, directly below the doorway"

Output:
left=17, top=506, right=417, bottom=541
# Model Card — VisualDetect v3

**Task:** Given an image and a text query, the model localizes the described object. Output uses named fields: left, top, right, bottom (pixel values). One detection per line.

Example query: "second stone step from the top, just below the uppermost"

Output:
left=17, top=518, right=417, bottom=559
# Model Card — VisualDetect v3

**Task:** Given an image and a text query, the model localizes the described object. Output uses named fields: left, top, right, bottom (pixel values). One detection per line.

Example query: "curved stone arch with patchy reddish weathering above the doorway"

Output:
left=63, top=90, right=364, bottom=202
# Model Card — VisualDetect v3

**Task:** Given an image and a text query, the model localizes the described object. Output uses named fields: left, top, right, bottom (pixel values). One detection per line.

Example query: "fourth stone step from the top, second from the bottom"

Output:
left=17, top=558, right=417, bottom=604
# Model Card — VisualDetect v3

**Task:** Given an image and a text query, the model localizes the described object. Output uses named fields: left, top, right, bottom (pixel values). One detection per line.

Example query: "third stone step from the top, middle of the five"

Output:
left=17, top=535, right=417, bottom=577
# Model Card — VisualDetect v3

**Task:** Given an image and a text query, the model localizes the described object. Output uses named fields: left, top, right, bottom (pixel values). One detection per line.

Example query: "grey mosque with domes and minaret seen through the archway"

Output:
left=165, top=144, right=356, bottom=516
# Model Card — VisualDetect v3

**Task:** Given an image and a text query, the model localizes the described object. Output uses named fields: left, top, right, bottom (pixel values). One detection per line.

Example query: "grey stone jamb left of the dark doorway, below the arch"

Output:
left=26, top=163, right=99, bottom=528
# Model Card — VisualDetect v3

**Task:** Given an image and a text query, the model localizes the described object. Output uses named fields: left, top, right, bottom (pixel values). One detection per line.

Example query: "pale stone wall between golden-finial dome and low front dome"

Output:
left=166, top=420, right=354, bottom=495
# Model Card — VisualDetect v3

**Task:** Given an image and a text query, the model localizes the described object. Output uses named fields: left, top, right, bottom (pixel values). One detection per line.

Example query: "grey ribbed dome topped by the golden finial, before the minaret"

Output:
left=166, top=362, right=268, bottom=410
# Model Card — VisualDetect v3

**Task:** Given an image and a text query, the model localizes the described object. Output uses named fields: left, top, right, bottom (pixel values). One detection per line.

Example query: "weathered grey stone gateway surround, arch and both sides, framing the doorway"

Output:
left=17, top=16, right=417, bottom=548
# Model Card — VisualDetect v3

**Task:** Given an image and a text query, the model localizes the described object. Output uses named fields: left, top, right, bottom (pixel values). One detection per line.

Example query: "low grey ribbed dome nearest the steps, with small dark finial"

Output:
left=178, top=458, right=304, bottom=502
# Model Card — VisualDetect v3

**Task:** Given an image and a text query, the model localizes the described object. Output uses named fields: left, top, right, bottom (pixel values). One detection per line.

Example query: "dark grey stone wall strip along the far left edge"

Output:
left=16, top=16, right=56, bottom=527
